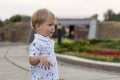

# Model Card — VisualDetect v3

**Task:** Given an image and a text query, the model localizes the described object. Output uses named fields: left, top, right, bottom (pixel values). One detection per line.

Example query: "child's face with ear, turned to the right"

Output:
left=36, top=21, right=56, bottom=37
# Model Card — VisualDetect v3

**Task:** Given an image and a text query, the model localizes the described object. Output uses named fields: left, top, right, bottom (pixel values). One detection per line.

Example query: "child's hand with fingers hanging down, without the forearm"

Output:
left=39, top=56, right=52, bottom=70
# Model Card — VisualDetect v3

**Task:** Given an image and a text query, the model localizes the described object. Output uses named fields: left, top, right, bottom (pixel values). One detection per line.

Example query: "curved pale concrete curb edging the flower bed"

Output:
left=56, top=54, right=120, bottom=72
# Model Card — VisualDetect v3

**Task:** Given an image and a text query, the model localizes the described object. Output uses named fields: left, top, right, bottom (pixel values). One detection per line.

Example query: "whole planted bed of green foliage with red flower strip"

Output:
left=55, top=39, right=120, bottom=62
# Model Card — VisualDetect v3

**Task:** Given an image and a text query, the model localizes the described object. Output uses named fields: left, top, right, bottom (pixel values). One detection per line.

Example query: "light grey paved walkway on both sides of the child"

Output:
left=0, top=45, right=120, bottom=80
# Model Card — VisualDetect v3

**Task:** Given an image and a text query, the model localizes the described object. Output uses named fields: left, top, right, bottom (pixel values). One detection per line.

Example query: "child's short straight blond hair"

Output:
left=31, top=8, right=56, bottom=29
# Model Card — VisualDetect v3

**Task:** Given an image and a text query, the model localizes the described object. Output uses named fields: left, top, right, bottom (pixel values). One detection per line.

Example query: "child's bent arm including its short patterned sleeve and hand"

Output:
left=29, top=42, right=51, bottom=69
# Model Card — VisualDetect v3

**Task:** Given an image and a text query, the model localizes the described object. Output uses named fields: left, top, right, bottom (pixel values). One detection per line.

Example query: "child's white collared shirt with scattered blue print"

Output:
left=29, top=34, right=59, bottom=80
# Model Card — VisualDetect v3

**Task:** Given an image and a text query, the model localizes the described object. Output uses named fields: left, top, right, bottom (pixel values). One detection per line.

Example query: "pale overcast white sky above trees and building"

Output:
left=0, top=0, right=120, bottom=20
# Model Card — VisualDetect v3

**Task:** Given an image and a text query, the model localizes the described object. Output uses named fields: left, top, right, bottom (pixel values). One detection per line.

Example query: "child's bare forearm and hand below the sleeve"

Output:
left=29, top=56, right=52, bottom=69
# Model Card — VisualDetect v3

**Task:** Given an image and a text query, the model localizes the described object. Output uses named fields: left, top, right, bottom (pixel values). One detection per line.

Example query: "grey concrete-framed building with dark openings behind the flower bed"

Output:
left=57, top=18, right=97, bottom=39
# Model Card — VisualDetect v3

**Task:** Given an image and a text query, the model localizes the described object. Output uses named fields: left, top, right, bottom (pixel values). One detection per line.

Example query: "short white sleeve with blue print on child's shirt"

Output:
left=29, top=42, right=42, bottom=56
